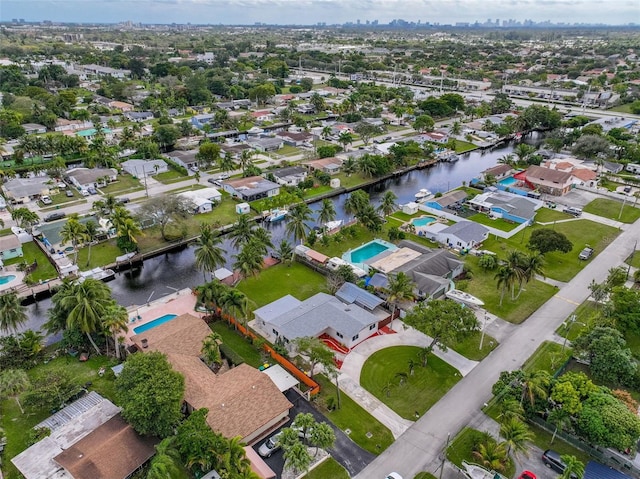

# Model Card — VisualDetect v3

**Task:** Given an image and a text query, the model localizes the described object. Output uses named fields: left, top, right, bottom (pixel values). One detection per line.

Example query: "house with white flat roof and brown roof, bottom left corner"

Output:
left=11, top=391, right=158, bottom=479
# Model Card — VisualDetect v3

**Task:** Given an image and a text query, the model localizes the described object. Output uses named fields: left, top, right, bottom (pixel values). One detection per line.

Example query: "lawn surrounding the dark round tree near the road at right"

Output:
left=482, top=220, right=620, bottom=284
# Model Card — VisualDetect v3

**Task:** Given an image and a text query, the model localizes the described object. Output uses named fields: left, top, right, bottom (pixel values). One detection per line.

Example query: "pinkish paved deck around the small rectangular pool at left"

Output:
left=124, top=288, right=204, bottom=346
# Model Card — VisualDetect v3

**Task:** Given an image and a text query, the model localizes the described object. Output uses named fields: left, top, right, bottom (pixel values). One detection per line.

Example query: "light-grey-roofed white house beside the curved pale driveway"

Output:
left=254, top=293, right=388, bottom=349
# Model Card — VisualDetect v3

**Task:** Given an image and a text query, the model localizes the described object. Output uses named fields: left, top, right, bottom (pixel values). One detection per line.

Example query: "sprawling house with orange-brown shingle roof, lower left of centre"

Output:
left=131, top=314, right=293, bottom=445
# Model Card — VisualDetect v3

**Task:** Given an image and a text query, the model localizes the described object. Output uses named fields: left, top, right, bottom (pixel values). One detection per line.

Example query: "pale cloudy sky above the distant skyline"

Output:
left=0, top=0, right=640, bottom=25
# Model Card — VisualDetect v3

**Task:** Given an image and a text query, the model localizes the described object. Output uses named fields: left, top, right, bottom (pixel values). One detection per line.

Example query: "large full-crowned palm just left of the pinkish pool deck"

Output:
left=56, top=278, right=113, bottom=354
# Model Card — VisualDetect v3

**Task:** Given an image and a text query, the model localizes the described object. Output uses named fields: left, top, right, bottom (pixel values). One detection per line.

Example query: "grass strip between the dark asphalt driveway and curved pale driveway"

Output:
left=314, top=374, right=393, bottom=454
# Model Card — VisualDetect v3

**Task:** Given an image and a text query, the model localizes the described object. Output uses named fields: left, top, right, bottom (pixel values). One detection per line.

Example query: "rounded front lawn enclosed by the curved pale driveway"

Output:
left=360, top=346, right=461, bottom=421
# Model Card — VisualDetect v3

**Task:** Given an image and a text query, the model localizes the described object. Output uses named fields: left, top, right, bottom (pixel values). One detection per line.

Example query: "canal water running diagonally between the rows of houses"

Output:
left=23, top=134, right=541, bottom=339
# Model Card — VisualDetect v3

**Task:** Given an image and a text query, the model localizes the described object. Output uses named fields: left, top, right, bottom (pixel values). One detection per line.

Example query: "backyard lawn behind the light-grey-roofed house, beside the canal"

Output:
left=237, top=262, right=327, bottom=309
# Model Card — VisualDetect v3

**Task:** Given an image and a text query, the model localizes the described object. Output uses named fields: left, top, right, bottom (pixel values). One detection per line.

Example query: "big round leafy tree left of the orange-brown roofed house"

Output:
left=115, top=352, right=184, bottom=438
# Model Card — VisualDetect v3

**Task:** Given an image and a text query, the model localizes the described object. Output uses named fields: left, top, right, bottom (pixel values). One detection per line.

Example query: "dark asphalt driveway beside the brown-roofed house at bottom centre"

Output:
left=253, top=390, right=376, bottom=477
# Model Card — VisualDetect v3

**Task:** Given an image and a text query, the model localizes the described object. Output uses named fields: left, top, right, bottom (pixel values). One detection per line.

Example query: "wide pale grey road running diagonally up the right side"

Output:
left=356, top=221, right=640, bottom=479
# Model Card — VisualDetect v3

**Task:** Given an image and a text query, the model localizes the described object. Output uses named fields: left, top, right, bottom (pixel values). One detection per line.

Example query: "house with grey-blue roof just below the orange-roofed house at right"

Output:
left=468, top=191, right=542, bottom=223
